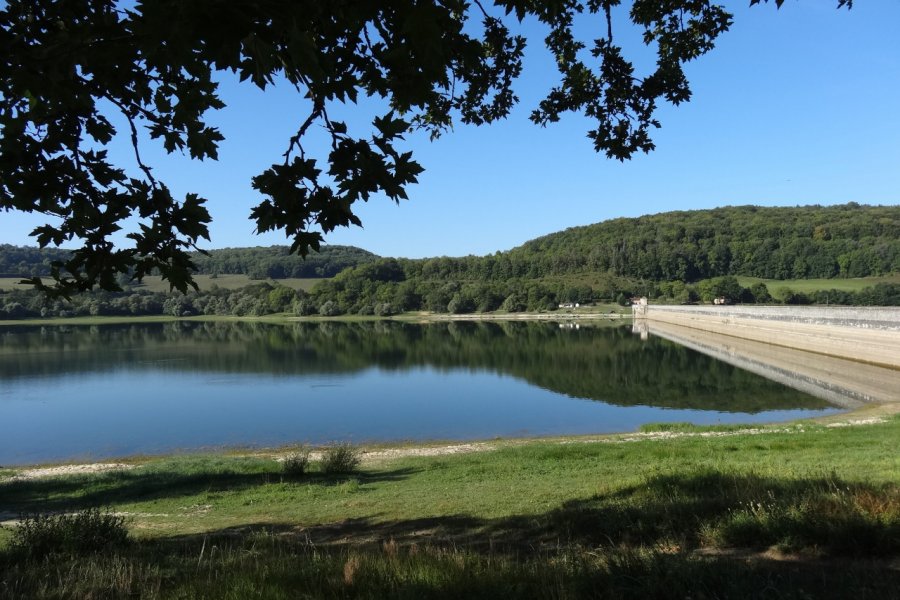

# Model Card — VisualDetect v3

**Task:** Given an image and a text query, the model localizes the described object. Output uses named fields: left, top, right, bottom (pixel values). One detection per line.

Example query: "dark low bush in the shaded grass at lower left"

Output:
left=10, top=508, right=128, bottom=558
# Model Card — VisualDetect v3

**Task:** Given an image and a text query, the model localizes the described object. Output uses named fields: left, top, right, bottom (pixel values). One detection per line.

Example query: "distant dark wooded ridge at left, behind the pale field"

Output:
left=0, top=244, right=378, bottom=279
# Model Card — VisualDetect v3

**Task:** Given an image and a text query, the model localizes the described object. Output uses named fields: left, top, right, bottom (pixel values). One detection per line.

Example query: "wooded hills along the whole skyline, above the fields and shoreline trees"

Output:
left=0, top=203, right=900, bottom=282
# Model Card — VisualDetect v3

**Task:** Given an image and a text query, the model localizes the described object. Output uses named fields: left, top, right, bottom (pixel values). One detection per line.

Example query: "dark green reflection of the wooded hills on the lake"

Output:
left=0, top=321, right=827, bottom=412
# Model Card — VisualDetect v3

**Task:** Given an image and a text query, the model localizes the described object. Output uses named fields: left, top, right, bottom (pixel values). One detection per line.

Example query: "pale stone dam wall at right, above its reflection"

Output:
left=634, top=304, right=900, bottom=370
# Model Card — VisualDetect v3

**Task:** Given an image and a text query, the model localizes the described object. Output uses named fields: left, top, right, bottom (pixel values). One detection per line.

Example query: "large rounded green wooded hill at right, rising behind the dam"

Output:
left=501, top=203, right=900, bottom=281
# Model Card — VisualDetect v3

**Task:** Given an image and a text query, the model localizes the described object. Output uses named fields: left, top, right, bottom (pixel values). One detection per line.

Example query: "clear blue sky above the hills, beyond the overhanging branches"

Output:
left=0, top=0, right=900, bottom=257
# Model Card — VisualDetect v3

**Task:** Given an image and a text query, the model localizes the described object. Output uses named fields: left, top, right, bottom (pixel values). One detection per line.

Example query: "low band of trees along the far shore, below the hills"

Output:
left=0, top=272, right=900, bottom=320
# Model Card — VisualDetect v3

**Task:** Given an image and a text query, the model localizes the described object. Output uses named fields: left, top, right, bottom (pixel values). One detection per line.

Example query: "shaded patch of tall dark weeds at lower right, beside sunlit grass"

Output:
left=546, top=471, right=900, bottom=557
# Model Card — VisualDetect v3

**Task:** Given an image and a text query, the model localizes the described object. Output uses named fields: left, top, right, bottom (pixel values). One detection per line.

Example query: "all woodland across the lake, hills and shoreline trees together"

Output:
left=0, top=204, right=900, bottom=319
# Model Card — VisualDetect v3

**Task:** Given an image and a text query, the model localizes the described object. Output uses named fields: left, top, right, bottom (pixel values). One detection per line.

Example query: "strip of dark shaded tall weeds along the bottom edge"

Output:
left=0, top=533, right=900, bottom=600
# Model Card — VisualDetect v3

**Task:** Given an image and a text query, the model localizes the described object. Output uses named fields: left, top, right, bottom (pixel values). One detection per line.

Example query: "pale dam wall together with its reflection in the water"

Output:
left=634, top=305, right=900, bottom=408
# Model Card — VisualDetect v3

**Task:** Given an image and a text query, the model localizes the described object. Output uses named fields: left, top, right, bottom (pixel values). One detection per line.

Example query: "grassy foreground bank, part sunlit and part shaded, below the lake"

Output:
left=0, top=416, right=900, bottom=598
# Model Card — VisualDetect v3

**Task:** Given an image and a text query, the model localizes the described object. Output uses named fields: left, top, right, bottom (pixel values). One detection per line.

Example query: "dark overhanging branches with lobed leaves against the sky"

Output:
left=0, top=0, right=800, bottom=293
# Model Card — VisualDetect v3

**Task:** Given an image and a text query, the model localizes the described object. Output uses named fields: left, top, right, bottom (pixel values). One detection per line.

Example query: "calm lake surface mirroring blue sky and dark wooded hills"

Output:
left=0, top=321, right=839, bottom=465
